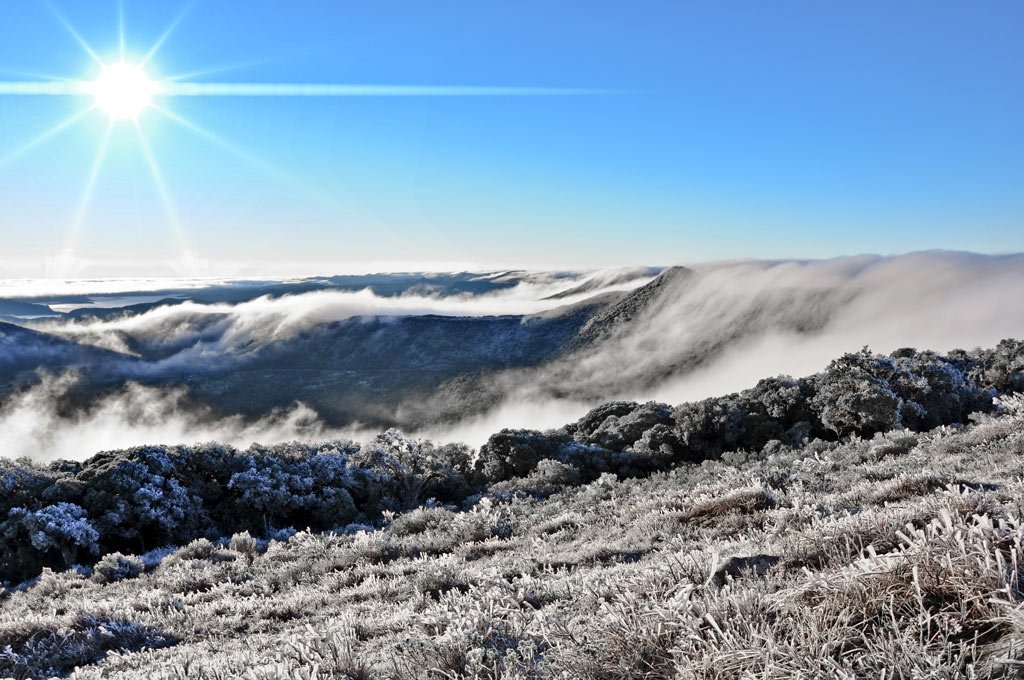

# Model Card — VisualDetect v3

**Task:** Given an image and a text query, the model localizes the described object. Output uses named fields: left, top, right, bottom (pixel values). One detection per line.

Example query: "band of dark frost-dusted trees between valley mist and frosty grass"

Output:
left=0, top=340, right=1024, bottom=583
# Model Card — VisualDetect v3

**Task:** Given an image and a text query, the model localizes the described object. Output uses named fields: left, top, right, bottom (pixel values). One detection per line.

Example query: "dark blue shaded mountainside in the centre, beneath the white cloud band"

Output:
left=177, top=294, right=617, bottom=427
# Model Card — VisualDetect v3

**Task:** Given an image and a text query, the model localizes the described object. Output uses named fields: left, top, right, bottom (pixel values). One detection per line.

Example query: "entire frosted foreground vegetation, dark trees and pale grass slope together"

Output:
left=0, top=341, right=1024, bottom=679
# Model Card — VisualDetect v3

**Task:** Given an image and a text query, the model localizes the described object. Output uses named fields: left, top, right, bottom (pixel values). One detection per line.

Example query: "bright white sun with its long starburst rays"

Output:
left=0, top=0, right=585, bottom=275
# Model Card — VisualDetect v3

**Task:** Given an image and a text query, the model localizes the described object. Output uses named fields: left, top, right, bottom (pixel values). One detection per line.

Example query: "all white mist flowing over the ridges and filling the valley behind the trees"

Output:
left=0, top=252, right=1024, bottom=460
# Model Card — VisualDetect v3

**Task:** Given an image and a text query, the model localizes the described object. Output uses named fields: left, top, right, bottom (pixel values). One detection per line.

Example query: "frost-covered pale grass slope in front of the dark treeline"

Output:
left=0, top=399, right=1024, bottom=680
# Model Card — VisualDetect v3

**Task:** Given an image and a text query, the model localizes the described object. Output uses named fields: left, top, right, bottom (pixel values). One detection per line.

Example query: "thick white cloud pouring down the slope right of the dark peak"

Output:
left=450, top=252, right=1024, bottom=443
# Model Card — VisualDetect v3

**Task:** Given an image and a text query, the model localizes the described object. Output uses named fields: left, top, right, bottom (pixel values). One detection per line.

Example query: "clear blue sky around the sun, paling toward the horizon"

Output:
left=0, top=0, right=1024, bottom=277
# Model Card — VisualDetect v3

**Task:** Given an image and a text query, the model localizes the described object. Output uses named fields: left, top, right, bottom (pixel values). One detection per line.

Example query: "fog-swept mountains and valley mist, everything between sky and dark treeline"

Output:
left=0, top=252, right=1024, bottom=459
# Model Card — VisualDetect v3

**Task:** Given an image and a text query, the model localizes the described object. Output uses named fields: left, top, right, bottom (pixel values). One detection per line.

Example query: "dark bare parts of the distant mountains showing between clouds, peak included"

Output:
left=0, top=267, right=847, bottom=428
